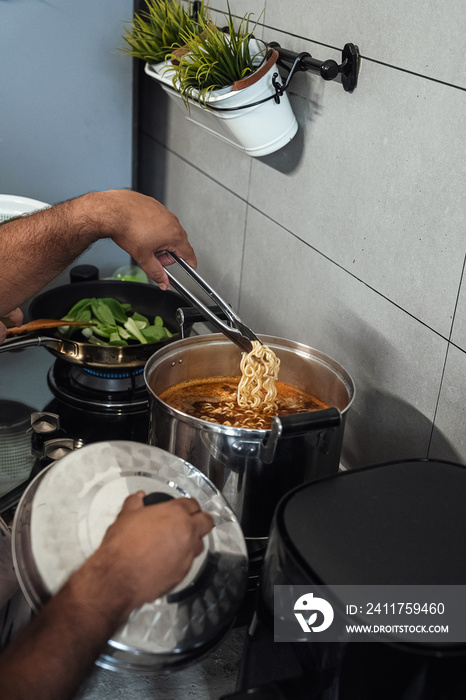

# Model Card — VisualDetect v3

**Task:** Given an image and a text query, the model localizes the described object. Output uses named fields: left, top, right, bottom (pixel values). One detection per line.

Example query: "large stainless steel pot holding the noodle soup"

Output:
left=145, top=334, right=354, bottom=539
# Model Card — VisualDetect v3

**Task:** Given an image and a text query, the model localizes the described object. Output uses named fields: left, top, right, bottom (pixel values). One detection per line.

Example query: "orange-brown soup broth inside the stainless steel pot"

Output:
left=160, top=377, right=328, bottom=429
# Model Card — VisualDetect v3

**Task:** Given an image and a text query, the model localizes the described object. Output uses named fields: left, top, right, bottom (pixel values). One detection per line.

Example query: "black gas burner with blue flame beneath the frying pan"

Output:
left=48, top=360, right=148, bottom=413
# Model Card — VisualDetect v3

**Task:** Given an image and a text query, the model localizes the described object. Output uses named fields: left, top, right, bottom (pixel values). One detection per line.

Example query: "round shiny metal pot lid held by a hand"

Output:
left=13, top=441, right=247, bottom=672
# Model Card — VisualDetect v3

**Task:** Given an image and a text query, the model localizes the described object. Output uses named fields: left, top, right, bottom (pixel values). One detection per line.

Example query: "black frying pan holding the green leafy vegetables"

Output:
left=0, top=280, right=189, bottom=368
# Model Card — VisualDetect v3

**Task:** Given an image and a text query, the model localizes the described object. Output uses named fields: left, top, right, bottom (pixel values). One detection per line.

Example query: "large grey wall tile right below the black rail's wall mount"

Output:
left=249, top=48, right=466, bottom=337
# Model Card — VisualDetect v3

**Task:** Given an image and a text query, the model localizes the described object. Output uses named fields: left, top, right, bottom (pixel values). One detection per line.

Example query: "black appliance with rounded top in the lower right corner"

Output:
left=225, top=460, right=466, bottom=700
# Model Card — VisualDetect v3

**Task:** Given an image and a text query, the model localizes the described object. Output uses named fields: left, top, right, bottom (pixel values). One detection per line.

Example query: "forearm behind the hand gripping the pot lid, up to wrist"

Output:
left=0, top=560, right=130, bottom=700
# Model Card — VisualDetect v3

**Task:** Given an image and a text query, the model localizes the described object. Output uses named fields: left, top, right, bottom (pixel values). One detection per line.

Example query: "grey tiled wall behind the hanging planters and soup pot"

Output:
left=139, top=0, right=466, bottom=467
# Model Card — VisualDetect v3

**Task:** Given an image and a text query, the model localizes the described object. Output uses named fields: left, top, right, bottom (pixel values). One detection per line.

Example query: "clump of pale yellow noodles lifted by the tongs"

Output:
left=238, top=340, right=280, bottom=415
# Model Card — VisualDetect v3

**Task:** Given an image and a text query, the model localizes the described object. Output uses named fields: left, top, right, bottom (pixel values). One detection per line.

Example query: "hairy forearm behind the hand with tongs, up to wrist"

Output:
left=0, top=194, right=101, bottom=316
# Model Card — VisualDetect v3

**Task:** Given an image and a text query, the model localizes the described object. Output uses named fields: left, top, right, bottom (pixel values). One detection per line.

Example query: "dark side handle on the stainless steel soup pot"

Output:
left=260, top=407, right=341, bottom=464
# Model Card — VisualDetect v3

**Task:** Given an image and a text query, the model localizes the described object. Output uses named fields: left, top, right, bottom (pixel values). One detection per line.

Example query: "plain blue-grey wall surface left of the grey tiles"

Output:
left=0, top=0, right=133, bottom=273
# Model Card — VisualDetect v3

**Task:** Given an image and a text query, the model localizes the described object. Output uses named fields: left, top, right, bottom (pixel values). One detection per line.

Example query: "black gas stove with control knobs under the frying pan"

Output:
left=0, top=350, right=149, bottom=515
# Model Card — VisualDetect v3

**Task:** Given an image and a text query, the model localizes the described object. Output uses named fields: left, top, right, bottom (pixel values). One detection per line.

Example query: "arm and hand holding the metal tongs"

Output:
left=0, top=190, right=196, bottom=316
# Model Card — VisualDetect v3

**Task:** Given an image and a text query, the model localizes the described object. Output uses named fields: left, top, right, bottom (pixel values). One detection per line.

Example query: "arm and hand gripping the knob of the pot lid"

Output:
left=0, top=492, right=213, bottom=700
